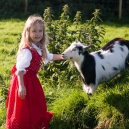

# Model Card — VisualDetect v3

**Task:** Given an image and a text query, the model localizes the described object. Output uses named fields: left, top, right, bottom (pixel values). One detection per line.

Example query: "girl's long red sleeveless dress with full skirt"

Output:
left=6, top=48, right=53, bottom=129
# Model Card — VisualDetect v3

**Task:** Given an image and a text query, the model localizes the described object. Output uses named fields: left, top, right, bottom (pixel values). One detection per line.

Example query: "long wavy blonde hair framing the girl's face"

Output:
left=19, top=14, right=48, bottom=59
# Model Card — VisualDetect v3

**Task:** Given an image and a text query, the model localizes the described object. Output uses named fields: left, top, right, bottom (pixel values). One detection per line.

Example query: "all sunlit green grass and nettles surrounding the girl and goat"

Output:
left=0, top=2, right=129, bottom=129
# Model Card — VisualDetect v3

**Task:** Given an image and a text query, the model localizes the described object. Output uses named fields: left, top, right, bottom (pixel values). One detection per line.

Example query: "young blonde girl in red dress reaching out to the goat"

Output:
left=6, top=15, right=62, bottom=129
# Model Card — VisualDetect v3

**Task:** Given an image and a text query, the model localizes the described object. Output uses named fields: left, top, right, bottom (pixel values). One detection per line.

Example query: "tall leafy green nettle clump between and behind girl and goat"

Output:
left=40, top=5, right=105, bottom=87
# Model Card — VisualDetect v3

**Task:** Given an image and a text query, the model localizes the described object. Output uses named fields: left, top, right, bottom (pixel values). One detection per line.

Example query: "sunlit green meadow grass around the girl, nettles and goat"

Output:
left=0, top=19, right=129, bottom=129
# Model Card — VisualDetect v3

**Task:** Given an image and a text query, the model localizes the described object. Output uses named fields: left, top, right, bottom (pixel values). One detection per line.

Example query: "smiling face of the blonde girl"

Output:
left=30, top=23, right=43, bottom=45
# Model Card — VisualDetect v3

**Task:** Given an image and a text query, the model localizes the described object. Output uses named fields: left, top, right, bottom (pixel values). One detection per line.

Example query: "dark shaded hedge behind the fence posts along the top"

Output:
left=0, top=0, right=129, bottom=21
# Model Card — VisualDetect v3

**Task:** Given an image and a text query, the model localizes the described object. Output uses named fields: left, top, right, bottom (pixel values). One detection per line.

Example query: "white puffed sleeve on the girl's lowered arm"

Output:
left=16, top=49, right=32, bottom=74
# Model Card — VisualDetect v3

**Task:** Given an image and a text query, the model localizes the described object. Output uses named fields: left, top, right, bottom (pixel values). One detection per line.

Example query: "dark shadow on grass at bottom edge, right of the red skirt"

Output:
left=50, top=111, right=98, bottom=129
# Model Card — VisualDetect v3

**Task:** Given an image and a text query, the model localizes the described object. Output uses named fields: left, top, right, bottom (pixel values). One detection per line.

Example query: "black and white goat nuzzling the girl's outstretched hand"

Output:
left=62, top=38, right=129, bottom=94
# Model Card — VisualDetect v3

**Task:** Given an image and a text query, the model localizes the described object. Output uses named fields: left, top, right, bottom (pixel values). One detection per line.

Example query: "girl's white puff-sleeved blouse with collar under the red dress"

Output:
left=16, top=43, right=53, bottom=73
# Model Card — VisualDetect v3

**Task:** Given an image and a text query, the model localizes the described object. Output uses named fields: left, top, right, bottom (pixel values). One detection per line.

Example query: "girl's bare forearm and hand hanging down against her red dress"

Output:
left=17, top=71, right=26, bottom=99
